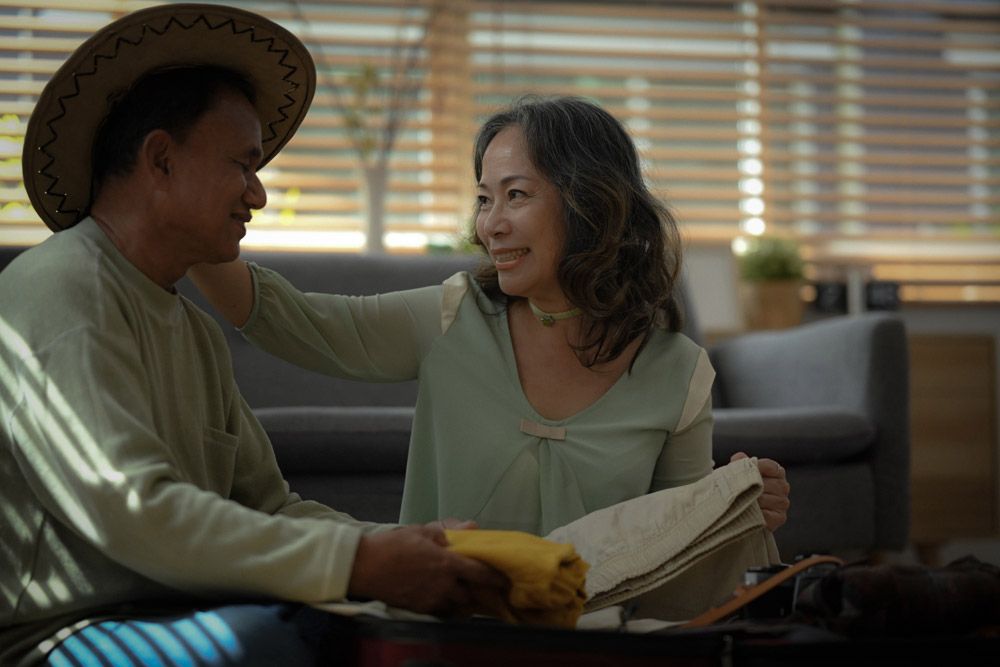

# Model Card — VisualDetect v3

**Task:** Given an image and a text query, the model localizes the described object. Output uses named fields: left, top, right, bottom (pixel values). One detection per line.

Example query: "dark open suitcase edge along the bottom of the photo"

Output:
left=322, top=616, right=1000, bottom=667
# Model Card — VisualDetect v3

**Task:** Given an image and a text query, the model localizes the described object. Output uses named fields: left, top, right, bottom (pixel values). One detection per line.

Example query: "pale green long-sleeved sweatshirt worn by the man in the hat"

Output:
left=0, top=219, right=376, bottom=664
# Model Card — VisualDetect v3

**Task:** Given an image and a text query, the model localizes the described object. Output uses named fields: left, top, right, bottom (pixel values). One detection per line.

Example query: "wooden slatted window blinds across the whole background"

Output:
left=0, top=0, right=1000, bottom=302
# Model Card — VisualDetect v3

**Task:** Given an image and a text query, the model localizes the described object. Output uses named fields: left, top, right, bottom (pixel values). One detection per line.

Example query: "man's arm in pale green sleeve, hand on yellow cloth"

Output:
left=5, top=320, right=503, bottom=613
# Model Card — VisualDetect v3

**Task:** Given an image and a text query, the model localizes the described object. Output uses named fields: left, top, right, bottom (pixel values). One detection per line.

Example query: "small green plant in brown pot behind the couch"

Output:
left=737, top=236, right=804, bottom=329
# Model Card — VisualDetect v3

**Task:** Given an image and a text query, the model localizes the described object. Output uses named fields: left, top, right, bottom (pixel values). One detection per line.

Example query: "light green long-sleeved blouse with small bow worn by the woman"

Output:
left=243, top=266, right=714, bottom=534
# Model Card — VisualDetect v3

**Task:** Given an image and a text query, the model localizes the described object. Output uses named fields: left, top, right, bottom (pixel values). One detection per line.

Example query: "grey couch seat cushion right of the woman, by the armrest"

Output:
left=712, top=407, right=875, bottom=465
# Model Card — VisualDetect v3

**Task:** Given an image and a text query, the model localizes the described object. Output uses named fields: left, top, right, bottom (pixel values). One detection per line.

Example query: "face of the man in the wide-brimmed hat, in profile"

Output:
left=167, top=92, right=267, bottom=264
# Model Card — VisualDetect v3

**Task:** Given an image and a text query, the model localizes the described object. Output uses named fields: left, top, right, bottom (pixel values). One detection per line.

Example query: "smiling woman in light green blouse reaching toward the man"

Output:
left=192, top=98, right=788, bottom=535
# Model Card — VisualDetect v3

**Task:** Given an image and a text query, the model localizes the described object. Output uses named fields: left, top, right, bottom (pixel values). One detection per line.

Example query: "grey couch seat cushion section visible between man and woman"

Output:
left=254, top=406, right=413, bottom=474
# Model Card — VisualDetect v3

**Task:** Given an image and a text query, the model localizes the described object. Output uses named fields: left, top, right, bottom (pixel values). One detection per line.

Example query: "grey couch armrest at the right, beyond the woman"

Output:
left=710, top=313, right=910, bottom=549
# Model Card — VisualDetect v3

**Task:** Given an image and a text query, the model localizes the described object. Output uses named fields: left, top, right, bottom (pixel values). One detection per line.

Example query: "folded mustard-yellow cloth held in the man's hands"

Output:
left=445, top=530, right=589, bottom=628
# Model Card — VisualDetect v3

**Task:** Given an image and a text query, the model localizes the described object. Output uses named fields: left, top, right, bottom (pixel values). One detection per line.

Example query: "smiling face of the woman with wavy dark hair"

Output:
left=476, top=125, right=571, bottom=312
